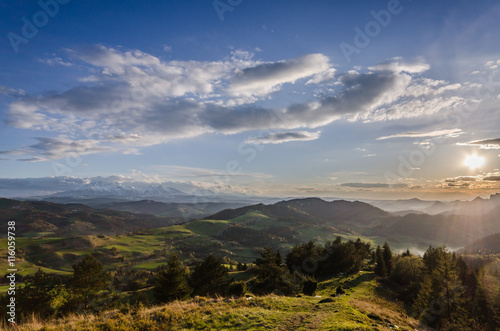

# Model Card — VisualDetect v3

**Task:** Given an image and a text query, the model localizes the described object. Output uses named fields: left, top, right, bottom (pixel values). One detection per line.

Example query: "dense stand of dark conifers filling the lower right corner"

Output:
left=375, top=246, right=500, bottom=331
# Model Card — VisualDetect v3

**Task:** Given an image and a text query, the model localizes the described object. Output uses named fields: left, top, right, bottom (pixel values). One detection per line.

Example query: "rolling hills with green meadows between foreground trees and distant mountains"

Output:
left=5, top=198, right=500, bottom=272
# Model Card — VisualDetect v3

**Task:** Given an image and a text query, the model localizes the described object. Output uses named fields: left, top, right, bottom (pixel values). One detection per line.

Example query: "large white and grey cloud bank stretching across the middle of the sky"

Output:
left=0, top=45, right=490, bottom=161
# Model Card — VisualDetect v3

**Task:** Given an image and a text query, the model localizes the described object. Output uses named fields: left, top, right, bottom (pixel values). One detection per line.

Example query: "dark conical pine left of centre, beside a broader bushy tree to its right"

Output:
left=154, top=254, right=192, bottom=302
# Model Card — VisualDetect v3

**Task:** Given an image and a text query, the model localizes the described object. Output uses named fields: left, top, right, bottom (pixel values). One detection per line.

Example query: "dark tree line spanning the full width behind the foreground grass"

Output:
left=0, top=237, right=500, bottom=330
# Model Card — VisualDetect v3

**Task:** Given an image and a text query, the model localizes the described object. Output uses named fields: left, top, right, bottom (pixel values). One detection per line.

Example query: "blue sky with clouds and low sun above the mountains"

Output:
left=0, top=0, right=500, bottom=200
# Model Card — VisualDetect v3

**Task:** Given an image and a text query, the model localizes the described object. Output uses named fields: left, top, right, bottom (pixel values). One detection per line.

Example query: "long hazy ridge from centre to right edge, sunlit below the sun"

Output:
left=206, top=195, right=500, bottom=248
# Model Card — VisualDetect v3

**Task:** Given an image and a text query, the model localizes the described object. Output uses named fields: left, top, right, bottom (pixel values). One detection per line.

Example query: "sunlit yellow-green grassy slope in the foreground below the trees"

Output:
left=6, top=272, right=422, bottom=330
